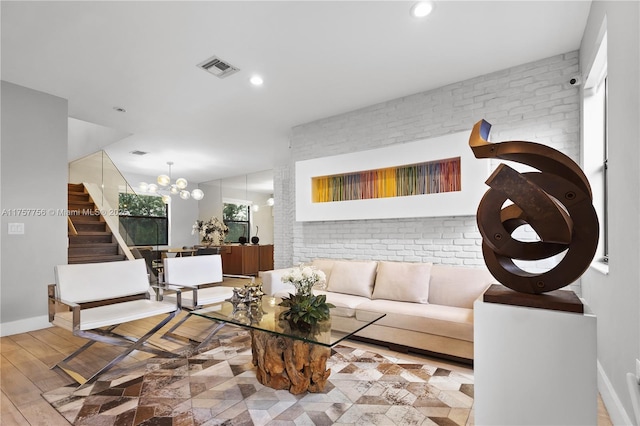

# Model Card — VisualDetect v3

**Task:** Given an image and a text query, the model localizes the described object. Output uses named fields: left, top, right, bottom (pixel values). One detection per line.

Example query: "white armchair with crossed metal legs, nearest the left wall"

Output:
left=48, top=259, right=181, bottom=385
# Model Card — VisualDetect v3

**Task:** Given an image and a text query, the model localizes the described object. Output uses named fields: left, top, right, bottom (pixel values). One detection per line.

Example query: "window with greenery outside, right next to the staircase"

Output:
left=119, top=193, right=169, bottom=246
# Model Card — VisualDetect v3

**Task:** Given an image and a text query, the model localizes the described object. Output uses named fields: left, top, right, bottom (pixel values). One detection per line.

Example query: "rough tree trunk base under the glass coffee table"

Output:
left=251, top=330, right=331, bottom=395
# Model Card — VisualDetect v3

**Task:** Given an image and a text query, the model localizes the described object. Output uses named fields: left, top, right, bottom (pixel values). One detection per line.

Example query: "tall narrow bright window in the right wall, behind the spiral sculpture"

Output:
left=582, top=33, right=610, bottom=264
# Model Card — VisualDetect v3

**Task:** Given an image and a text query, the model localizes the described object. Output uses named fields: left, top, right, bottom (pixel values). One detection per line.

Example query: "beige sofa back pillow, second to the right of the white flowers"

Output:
left=373, top=261, right=432, bottom=303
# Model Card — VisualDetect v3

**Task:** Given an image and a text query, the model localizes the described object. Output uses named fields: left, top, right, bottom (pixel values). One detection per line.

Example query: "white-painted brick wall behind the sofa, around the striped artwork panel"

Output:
left=274, top=52, right=580, bottom=290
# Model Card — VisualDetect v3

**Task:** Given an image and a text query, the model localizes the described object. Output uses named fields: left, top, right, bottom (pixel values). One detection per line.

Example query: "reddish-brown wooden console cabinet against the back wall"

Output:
left=220, top=244, right=273, bottom=275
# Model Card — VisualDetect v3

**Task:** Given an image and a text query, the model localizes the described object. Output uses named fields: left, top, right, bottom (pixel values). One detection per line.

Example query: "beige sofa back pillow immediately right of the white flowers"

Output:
left=327, top=260, right=378, bottom=298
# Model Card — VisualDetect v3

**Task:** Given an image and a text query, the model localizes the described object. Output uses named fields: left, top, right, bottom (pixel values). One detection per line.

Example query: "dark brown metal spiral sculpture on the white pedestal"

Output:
left=469, top=120, right=599, bottom=294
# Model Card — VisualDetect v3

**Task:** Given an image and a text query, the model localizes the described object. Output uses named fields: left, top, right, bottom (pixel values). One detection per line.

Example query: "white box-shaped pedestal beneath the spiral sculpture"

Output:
left=474, top=286, right=598, bottom=426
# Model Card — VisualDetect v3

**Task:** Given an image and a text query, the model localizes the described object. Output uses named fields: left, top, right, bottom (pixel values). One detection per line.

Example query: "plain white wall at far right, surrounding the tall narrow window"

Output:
left=580, top=1, right=640, bottom=424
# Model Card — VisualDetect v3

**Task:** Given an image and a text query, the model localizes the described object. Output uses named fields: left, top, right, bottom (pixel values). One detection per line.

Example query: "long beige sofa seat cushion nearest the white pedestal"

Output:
left=356, top=300, right=473, bottom=342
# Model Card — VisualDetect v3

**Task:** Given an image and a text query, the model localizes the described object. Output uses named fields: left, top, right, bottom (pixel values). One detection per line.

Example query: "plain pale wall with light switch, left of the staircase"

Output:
left=0, top=81, right=68, bottom=335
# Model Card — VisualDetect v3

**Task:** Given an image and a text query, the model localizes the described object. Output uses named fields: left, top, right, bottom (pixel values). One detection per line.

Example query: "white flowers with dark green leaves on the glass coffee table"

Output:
left=280, top=265, right=335, bottom=331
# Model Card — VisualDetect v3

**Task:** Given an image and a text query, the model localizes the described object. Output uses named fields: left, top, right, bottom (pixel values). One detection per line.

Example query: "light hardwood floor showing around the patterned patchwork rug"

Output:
left=0, top=314, right=611, bottom=426
